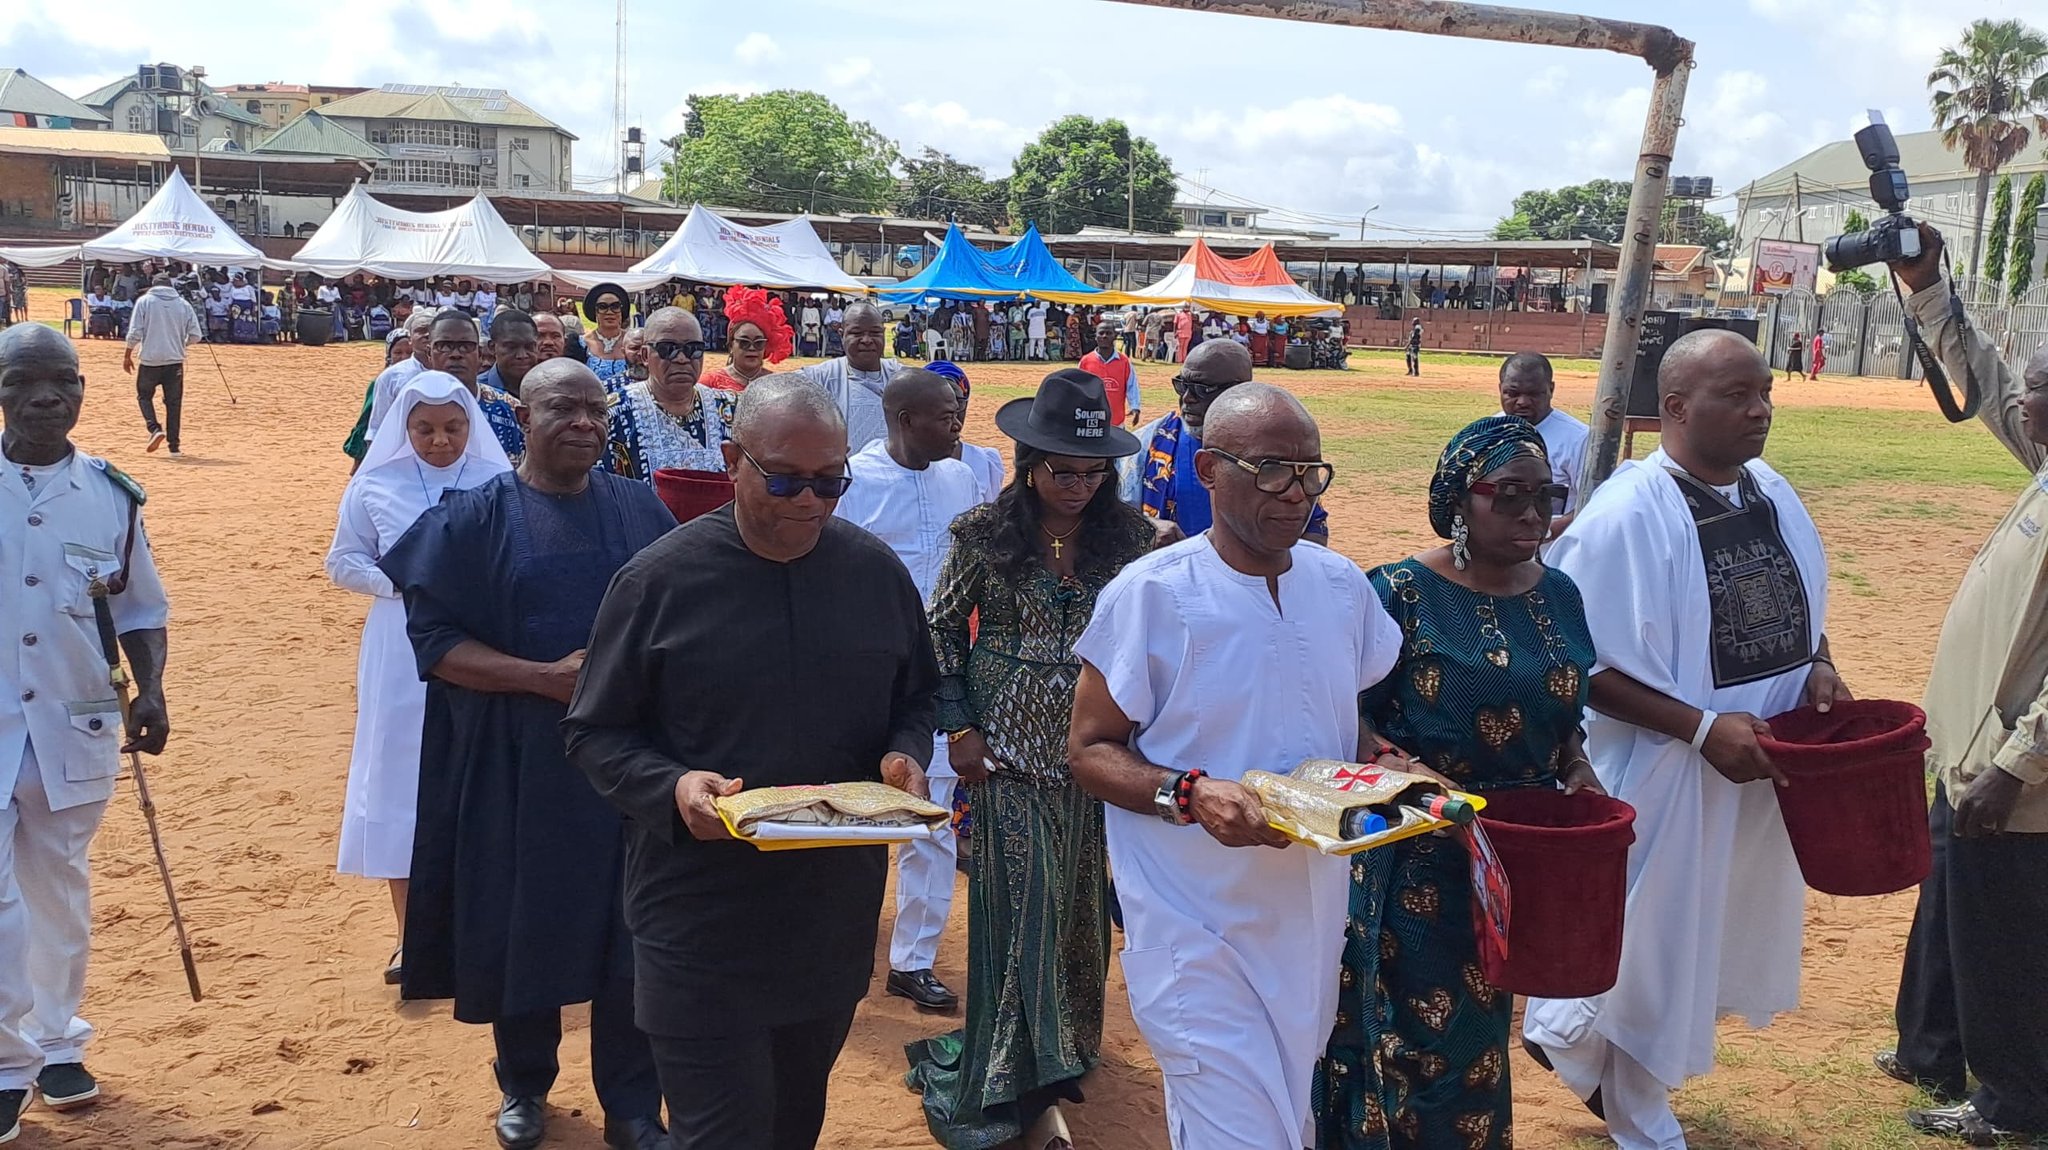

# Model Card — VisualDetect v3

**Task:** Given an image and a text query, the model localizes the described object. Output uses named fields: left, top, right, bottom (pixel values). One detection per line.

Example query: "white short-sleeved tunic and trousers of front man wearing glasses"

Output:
left=1075, top=534, right=1401, bottom=1150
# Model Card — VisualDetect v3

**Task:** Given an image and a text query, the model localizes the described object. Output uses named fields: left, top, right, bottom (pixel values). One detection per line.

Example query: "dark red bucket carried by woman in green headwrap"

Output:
left=1479, top=790, right=1636, bottom=999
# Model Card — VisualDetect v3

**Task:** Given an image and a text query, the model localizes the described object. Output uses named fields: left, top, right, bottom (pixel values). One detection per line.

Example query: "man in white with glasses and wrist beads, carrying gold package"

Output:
left=1069, top=383, right=1401, bottom=1150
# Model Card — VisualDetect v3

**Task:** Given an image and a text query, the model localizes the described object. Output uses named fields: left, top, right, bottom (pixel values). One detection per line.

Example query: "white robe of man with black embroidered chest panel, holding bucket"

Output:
left=1526, top=450, right=1827, bottom=1088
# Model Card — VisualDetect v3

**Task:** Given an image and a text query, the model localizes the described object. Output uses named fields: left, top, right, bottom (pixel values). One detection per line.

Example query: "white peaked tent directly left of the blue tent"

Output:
left=555, top=205, right=868, bottom=295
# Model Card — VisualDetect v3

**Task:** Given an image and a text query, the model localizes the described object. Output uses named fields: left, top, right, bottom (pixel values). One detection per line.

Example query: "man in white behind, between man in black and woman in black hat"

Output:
left=831, top=368, right=981, bottom=1011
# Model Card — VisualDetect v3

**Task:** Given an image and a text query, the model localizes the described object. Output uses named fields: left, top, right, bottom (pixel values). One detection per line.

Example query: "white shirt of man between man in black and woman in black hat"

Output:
left=831, top=440, right=981, bottom=606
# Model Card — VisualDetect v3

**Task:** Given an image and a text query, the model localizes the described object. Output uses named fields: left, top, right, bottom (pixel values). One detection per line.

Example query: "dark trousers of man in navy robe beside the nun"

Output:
left=492, top=982, right=662, bottom=1119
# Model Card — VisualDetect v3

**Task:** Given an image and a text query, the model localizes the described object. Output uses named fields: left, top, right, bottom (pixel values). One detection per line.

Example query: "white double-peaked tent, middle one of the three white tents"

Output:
left=291, top=184, right=551, bottom=284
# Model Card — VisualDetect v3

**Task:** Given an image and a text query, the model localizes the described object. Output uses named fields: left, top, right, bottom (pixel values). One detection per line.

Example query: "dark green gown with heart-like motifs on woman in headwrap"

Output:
left=1317, top=559, right=1593, bottom=1150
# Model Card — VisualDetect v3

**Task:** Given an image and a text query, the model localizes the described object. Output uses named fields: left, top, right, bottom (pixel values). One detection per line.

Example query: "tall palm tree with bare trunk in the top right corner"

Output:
left=1927, top=20, right=2048, bottom=276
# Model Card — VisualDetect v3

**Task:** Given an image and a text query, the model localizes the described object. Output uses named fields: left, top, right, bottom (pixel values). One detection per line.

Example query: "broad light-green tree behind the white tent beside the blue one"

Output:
left=662, top=88, right=897, bottom=213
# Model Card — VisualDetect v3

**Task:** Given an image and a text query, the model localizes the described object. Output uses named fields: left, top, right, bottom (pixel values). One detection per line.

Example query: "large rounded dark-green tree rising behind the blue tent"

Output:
left=1010, top=117, right=1180, bottom=233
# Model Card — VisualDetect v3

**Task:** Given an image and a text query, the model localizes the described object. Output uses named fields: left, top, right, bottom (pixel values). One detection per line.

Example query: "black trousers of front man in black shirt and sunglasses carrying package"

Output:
left=651, top=1007, right=854, bottom=1150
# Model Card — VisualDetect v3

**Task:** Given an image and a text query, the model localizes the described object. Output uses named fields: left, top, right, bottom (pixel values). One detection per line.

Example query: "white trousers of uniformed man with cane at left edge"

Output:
left=0, top=745, right=106, bottom=1091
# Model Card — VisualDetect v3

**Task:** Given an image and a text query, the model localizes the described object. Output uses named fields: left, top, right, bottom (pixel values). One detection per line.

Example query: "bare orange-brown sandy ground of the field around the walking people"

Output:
left=4, top=311, right=2003, bottom=1150
